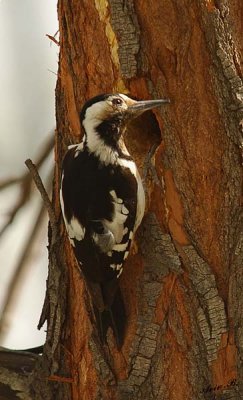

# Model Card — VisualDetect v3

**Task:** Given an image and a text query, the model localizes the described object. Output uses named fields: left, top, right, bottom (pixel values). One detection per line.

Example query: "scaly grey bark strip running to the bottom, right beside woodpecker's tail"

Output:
left=118, top=213, right=182, bottom=400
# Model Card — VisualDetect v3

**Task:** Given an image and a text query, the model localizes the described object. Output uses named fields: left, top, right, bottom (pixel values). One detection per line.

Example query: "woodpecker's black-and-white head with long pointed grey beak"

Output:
left=80, top=93, right=170, bottom=162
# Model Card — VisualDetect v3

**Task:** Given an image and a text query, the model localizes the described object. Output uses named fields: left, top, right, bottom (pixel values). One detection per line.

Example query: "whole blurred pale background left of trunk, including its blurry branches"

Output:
left=0, top=0, right=59, bottom=349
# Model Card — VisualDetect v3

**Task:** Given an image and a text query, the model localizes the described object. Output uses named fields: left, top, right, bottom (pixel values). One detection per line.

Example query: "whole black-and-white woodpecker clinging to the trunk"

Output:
left=60, top=94, right=169, bottom=349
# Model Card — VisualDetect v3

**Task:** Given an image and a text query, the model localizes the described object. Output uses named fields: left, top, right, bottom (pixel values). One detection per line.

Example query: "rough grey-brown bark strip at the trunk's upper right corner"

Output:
left=199, top=1, right=243, bottom=146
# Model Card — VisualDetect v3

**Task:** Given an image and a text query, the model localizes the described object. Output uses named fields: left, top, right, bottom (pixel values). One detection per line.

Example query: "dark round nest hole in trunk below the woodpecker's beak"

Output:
left=125, top=111, right=161, bottom=165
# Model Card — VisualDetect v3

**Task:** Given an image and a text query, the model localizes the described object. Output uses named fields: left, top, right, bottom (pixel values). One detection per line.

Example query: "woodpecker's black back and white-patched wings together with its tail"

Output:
left=60, top=145, right=137, bottom=347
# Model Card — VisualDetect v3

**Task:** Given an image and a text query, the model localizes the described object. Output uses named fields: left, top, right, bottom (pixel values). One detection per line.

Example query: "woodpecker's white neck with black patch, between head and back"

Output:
left=85, top=118, right=131, bottom=165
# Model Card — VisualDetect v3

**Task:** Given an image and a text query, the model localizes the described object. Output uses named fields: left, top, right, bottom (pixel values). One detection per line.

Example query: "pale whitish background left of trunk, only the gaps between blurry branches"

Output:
left=0, top=0, right=58, bottom=349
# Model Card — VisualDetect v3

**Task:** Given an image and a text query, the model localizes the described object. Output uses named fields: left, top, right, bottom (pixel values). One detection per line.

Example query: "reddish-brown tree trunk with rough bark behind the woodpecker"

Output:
left=0, top=0, right=243, bottom=400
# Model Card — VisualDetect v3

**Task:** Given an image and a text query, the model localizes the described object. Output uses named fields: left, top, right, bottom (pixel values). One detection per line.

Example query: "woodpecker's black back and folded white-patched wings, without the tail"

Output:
left=60, top=145, right=137, bottom=277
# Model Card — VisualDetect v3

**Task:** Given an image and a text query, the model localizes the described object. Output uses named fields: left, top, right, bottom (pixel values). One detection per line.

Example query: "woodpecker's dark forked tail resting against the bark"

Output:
left=94, top=284, right=126, bottom=349
